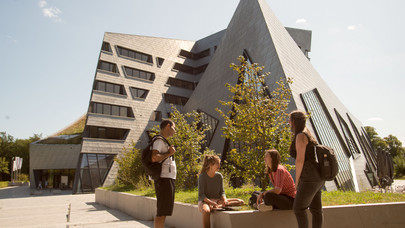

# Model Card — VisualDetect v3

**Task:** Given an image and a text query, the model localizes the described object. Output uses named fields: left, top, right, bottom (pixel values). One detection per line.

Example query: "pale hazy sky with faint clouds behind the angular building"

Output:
left=0, top=0, right=405, bottom=143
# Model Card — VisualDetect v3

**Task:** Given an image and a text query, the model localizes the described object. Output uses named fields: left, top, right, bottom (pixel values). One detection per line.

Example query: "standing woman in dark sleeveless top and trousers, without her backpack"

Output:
left=289, top=111, right=325, bottom=228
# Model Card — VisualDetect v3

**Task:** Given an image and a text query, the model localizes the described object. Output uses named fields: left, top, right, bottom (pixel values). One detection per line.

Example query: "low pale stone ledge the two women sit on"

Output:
left=95, top=189, right=405, bottom=228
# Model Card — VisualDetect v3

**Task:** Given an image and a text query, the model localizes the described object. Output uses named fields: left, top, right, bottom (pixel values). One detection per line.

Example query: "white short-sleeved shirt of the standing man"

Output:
left=152, top=139, right=177, bottom=179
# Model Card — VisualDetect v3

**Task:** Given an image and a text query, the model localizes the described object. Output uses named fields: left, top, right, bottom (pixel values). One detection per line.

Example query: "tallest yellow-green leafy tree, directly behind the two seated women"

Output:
left=217, top=56, right=292, bottom=189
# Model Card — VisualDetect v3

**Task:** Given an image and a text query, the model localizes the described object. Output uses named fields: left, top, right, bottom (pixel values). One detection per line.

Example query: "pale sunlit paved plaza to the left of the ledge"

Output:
left=0, top=186, right=164, bottom=228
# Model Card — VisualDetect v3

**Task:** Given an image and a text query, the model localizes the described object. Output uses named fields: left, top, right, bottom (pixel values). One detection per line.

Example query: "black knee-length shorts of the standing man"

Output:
left=155, top=178, right=176, bottom=216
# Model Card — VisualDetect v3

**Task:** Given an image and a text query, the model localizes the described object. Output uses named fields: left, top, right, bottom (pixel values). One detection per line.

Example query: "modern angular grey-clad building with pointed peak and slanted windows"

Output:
left=32, top=0, right=376, bottom=193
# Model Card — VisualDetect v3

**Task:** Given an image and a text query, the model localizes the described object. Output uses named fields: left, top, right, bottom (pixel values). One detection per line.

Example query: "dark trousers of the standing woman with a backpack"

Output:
left=293, top=181, right=325, bottom=228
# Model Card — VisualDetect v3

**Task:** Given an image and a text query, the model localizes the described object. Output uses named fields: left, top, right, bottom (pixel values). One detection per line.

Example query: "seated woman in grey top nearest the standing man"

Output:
left=198, top=155, right=244, bottom=228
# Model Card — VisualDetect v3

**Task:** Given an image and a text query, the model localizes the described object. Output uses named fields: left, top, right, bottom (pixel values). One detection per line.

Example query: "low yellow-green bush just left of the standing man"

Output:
left=114, top=143, right=149, bottom=187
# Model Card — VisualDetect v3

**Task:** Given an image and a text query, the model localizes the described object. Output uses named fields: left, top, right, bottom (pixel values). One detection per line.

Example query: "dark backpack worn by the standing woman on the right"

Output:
left=314, top=144, right=339, bottom=181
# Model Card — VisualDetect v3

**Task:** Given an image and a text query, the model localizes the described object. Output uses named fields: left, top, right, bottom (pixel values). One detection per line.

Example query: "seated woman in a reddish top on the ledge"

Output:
left=257, top=149, right=296, bottom=212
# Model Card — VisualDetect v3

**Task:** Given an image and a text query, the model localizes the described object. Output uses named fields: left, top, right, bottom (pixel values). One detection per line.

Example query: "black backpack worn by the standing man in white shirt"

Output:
left=142, top=135, right=170, bottom=181
